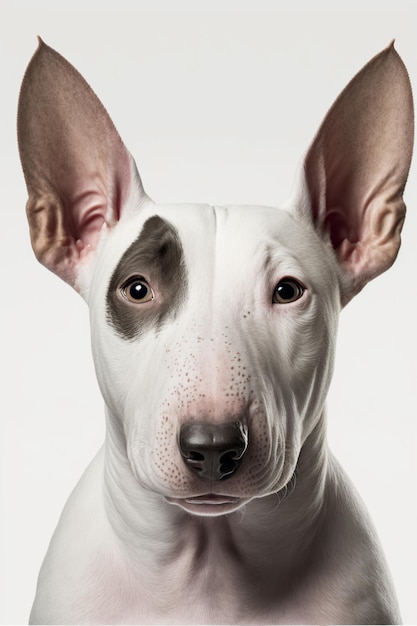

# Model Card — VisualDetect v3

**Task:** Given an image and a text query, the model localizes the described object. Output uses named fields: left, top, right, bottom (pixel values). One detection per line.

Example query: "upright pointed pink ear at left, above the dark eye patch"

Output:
left=18, top=40, right=146, bottom=288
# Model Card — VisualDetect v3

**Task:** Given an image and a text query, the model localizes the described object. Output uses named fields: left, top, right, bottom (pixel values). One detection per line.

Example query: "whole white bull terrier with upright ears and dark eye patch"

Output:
left=18, top=40, right=413, bottom=624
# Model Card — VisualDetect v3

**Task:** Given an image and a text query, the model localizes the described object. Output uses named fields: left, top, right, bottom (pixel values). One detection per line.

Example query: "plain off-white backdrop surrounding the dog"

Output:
left=0, top=0, right=417, bottom=624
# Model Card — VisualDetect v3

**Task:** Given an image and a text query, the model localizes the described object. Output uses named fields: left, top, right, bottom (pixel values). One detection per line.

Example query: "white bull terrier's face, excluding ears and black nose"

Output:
left=88, top=203, right=340, bottom=511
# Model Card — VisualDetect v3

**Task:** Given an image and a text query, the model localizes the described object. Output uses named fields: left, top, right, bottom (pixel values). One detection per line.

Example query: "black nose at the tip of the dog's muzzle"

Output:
left=179, top=422, right=248, bottom=482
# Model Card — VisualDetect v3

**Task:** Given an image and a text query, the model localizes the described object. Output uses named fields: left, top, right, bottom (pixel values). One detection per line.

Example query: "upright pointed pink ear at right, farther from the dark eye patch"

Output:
left=298, top=45, right=414, bottom=304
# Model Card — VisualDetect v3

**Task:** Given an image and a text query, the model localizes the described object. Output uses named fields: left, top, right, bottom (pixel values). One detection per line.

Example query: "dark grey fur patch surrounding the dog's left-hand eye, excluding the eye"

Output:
left=106, top=215, right=187, bottom=340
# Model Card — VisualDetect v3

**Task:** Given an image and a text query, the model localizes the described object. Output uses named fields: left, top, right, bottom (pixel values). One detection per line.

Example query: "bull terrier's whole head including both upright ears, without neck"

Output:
left=18, top=42, right=413, bottom=514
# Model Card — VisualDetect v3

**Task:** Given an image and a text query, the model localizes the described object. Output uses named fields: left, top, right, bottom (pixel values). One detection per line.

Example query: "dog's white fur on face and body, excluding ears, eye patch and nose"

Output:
left=31, top=204, right=395, bottom=624
